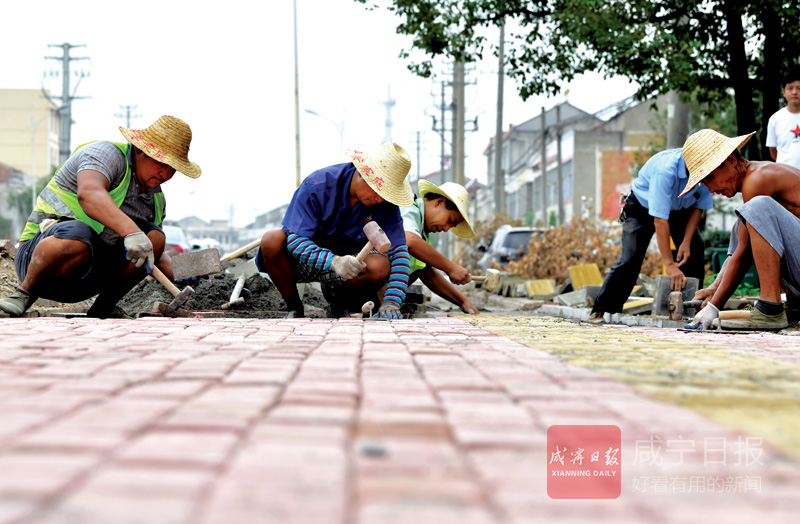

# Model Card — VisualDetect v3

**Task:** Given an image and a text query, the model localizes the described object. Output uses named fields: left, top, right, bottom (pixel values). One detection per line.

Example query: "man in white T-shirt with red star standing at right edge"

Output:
left=767, top=68, right=800, bottom=168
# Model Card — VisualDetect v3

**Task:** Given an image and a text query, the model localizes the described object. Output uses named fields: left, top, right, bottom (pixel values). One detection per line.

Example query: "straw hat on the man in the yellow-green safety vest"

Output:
left=119, top=115, right=205, bottom=178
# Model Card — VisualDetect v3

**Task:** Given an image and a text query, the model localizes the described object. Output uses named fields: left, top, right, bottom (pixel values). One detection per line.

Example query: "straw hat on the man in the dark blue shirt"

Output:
left=345, top=142, right=414, bottom=206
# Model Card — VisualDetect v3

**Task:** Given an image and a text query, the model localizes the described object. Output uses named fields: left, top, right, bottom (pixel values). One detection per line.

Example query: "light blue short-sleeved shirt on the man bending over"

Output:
left=631, top=149, right=713, bottom=220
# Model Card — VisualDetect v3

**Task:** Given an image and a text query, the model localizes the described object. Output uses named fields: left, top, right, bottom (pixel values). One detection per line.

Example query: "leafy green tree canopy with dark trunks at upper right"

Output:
left=356, top=0, right=800, bottom=158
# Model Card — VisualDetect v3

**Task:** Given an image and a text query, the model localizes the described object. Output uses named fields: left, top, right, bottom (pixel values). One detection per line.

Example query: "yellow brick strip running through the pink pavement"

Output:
left=464, top=315, right=800, bottom=458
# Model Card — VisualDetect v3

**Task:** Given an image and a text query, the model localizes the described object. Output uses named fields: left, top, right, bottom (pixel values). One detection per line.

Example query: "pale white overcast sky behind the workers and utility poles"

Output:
left=0, top=0, right=635, bottom=226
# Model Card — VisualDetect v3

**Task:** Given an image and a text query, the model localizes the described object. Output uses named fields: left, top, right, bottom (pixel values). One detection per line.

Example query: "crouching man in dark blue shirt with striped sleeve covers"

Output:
left=256, top=142, right=414, bottom=318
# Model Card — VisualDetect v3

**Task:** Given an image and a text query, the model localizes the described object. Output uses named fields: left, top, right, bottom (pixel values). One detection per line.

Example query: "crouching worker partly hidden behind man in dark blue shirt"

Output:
left=400, top=180, right=478, bottom=314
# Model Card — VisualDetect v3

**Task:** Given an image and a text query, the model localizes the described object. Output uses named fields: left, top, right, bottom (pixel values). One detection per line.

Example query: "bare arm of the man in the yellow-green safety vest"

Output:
left=78, top=169, right=141, bottom=238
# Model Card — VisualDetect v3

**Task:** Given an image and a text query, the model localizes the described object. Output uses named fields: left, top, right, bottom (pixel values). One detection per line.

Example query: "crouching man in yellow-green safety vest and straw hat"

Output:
left=0, top=116, right=200, bottom=318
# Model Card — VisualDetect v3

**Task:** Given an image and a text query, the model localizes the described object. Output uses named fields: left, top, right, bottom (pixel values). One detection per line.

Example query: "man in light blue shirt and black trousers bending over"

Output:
left=589, top=145, right=712, bottom=322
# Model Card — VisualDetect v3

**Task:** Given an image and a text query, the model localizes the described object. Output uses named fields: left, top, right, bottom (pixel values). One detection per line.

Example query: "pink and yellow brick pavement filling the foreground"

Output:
left=0, top=316, right=800, bottom=524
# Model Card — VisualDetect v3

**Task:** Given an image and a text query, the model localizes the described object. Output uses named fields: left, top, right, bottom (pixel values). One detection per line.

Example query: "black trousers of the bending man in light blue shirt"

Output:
left=592, top=193, right=705, bottom=313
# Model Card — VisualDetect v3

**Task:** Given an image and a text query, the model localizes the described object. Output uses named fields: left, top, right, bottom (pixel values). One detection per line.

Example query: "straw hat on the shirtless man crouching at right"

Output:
left=678, top=129, right=755, bottom=198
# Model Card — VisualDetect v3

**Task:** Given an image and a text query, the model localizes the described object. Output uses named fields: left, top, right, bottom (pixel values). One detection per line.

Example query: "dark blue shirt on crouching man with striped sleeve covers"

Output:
left=283, top=162, right=406, bottom=255
